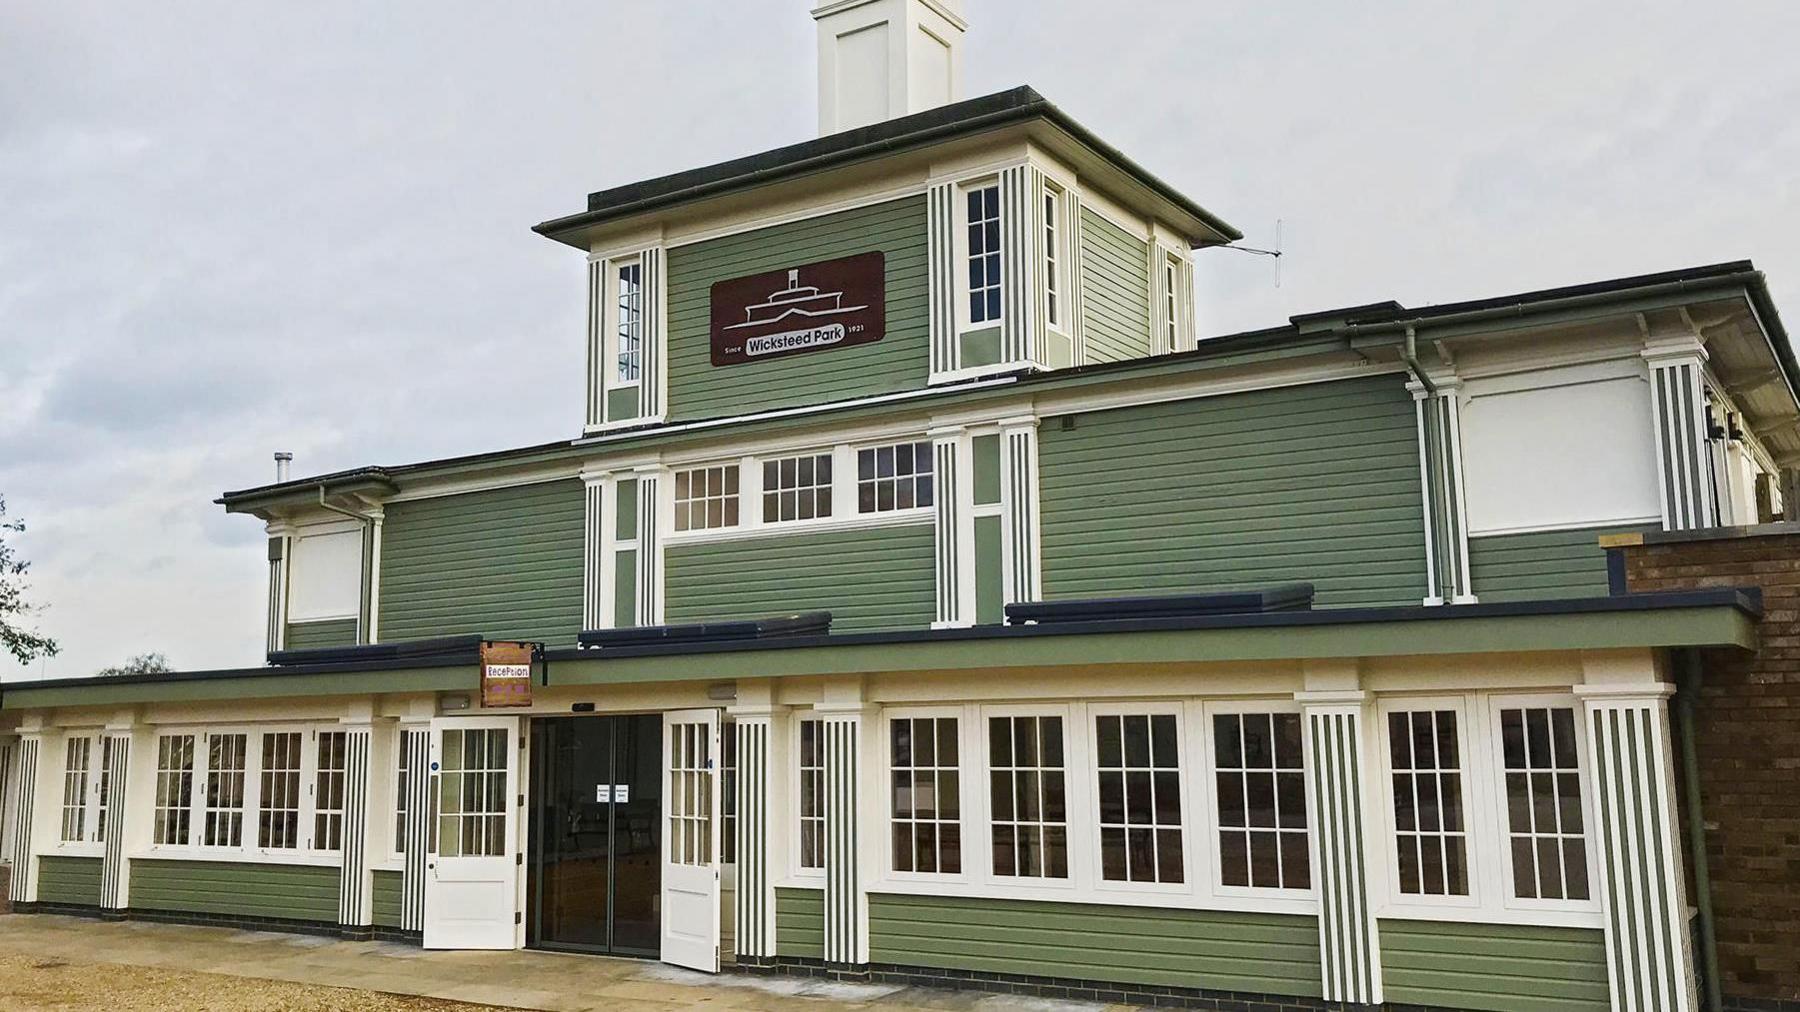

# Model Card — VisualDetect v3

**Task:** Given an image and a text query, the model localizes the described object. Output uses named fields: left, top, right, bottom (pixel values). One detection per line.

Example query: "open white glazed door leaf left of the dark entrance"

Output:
left=425, top=717, right=520, bottom=949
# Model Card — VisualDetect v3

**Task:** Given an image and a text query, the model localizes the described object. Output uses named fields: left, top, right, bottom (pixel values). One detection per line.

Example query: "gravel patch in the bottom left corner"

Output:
left=0, top=953, right=493, bottom=1012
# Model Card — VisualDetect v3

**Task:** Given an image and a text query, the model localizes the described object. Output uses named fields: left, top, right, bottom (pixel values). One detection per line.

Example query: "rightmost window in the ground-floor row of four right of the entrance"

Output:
left=1213, top=713, right=1312, bottom=890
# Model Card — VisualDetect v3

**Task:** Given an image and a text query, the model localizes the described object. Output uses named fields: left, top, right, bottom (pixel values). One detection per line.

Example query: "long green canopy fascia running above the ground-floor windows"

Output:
left=0, top=589, right=1762, bottom=711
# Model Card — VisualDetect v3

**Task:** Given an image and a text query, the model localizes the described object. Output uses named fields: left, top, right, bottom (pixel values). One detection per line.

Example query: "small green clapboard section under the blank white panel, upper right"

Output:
left=1469, top=526, right=1645, bottom=601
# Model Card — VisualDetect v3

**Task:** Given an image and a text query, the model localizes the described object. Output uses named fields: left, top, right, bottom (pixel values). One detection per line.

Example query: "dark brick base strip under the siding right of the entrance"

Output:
left=738, top=956, right=1354, bottom=1012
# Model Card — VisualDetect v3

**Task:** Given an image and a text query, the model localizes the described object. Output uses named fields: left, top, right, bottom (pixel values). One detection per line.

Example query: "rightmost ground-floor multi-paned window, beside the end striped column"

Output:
left=1499, top=706, right=1588, bottom=900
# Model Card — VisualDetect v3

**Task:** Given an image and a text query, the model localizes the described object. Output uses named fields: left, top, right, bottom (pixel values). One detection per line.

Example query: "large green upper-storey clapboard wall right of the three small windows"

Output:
left=1039, top=376, right=1426, bottom=607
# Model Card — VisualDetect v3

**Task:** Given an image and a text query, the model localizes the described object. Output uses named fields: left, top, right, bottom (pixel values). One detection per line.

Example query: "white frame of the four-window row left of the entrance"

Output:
left=131, top=722, right=344, bottom=864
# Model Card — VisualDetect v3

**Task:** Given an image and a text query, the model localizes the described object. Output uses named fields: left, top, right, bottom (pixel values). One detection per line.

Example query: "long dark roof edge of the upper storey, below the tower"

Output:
left=214, top=259, right=1800, bottom=506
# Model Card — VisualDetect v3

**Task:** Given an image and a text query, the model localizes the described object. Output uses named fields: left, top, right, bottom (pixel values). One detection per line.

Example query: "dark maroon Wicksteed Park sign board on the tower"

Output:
left=713, top=250, right=887, bottom=366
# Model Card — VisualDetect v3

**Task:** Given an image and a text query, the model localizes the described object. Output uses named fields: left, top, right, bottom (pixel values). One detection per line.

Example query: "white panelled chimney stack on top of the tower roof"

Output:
left=812, top=0, right=968, bottom=137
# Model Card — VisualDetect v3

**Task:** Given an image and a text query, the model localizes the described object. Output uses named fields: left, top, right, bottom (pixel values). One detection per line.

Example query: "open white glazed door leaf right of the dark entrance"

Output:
left=662, top=709, right=718, bottom=972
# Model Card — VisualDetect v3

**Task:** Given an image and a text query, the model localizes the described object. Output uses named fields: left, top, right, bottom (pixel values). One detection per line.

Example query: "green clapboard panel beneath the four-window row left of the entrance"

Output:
left=131, top=861, right=338, bottom=924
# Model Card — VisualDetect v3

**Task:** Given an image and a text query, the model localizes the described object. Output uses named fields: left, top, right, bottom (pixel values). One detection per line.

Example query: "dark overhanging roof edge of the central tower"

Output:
left=531, top=85, right=1244, bottom=241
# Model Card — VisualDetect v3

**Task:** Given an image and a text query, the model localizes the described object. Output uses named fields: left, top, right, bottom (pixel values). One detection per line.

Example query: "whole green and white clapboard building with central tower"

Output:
left=0, top=0, right=1800, bottom=1010
